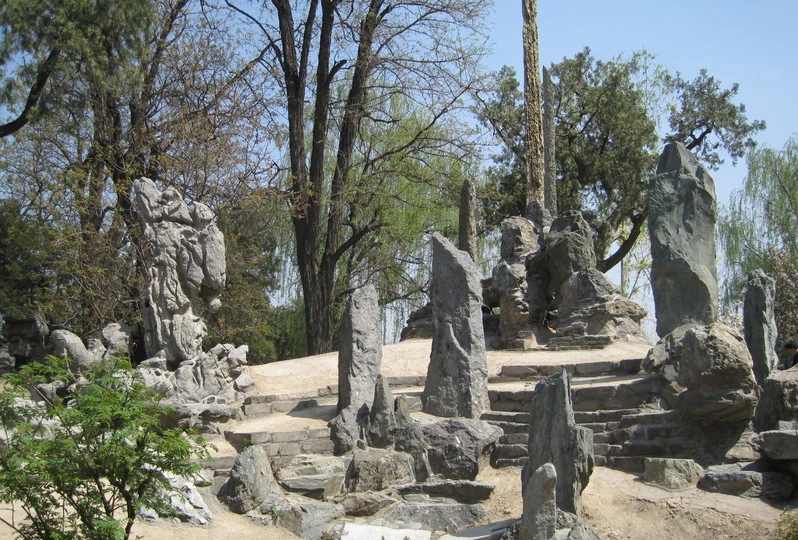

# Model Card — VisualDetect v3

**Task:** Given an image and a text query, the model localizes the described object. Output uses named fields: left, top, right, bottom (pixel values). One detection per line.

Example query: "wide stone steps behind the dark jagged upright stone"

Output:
left=482, top=359, right=694, bottom=472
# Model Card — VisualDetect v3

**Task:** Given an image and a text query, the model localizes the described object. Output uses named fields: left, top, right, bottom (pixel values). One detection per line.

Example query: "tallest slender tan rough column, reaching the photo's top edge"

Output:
left=522, top=0, right=545, bottom=204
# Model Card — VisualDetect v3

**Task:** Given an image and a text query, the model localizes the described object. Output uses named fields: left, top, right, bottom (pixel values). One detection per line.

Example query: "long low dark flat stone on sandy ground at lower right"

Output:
left=698, top=465, right=795, bottom=501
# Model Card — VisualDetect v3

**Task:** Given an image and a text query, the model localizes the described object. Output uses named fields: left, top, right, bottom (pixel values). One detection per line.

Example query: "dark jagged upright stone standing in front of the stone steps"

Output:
left=521, top=370, right=594, bottom=515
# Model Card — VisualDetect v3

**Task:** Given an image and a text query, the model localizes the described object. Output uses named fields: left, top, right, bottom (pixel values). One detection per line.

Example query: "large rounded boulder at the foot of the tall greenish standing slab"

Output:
left=643, top=323, right=757, bottom=424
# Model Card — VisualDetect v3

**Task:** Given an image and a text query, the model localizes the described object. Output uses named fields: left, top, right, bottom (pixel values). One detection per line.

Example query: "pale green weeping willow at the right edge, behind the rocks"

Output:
left=718, top=136, right=798, bottom=338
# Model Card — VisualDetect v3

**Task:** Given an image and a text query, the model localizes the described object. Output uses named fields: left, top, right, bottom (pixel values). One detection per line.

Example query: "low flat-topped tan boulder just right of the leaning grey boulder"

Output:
left=275, top=454, right=347, bottom=499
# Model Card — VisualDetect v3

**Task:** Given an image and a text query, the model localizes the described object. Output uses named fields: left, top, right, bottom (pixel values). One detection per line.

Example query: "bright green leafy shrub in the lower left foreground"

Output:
left=0, top=357, right=206, bottom=540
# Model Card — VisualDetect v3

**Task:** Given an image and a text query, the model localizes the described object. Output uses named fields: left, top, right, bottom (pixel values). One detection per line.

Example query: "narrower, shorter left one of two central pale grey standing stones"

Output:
left=330, top=283, right=382, bottom=454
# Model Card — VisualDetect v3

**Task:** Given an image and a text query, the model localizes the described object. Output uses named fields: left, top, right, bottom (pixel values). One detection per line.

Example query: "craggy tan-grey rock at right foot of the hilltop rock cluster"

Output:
left=552, top=268, right=646, bottom=339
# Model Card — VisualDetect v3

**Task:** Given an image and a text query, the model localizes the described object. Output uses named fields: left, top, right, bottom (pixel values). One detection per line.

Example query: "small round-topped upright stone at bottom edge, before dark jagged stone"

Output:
left=520, top=463, right=557, bottom=540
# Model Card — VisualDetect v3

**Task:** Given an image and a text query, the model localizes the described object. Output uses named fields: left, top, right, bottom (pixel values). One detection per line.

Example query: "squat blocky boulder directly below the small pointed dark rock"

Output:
left=345, top=448, right=415, bottom=491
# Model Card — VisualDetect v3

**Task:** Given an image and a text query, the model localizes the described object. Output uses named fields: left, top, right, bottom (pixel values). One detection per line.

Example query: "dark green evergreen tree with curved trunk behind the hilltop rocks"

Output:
left=478, top=49, right=764, bottom=271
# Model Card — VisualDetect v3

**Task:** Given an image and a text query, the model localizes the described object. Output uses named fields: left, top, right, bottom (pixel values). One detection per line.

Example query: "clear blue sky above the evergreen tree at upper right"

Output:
left=489, top=0, right=798, bottom=204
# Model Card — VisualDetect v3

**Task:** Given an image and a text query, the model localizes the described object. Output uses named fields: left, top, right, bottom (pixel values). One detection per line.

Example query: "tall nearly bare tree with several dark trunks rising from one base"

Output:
left=228, top=0, right=488, bottom=354
